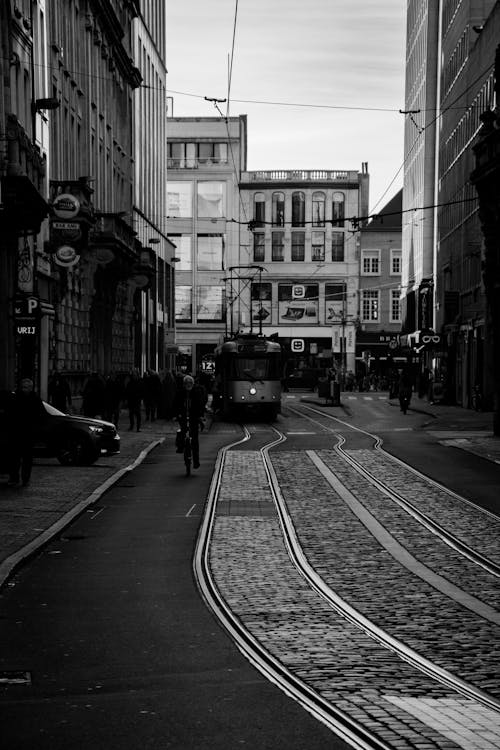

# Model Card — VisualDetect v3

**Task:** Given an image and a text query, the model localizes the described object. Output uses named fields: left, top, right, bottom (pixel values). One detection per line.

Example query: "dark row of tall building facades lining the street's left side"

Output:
left=0, top=0, right=174, bottom=396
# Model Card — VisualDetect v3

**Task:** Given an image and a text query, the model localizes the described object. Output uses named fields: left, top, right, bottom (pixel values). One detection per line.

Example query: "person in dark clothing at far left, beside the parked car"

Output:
left=6, top=378, right=47, bottom=487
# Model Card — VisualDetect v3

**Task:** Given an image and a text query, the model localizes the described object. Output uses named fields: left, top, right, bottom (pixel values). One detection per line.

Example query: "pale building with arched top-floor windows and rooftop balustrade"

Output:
left=238, top=164, right=369, bottom=371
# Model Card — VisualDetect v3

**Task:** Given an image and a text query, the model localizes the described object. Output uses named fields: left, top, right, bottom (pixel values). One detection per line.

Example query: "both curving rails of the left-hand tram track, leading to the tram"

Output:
left=194, top=420, right=500, bottom=750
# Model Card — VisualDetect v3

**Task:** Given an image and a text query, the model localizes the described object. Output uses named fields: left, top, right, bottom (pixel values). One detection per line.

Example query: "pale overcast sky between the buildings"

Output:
left=167, top=0, right=406, bottom=210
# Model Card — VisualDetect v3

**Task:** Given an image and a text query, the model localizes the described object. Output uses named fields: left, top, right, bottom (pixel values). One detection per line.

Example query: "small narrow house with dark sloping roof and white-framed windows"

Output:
left=356, top=190, right=406, bottom=375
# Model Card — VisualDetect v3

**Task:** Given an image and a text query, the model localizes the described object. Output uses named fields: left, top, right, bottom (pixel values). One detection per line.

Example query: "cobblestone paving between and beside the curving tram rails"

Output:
left=211, top=422, right=500, bottom=750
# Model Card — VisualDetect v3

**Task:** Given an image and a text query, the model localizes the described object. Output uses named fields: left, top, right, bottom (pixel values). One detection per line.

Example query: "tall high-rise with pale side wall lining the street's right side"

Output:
left=402, top=0, right=500, bottom=407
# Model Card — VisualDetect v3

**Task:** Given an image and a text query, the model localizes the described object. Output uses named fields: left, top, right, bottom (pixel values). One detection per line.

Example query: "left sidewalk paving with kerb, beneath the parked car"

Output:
left=0, top=417, right=177, bottom=586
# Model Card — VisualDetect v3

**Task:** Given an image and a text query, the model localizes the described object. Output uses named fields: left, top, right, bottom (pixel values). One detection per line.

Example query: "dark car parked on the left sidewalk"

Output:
left=0, top=401, right=120, bottom=466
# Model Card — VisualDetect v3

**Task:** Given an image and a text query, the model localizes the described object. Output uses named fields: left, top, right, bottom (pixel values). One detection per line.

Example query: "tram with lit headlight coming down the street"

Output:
left=214, top=333, right=282, bottom=420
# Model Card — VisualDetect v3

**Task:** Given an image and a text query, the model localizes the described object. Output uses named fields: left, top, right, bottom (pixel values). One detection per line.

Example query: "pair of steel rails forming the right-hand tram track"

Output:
left=288, top=406, right=500, bottom=578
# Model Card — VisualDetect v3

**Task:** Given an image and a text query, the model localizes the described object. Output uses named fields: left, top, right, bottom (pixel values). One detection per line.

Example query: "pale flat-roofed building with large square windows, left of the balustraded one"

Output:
left=166, top=115, right=247, bottom=371
